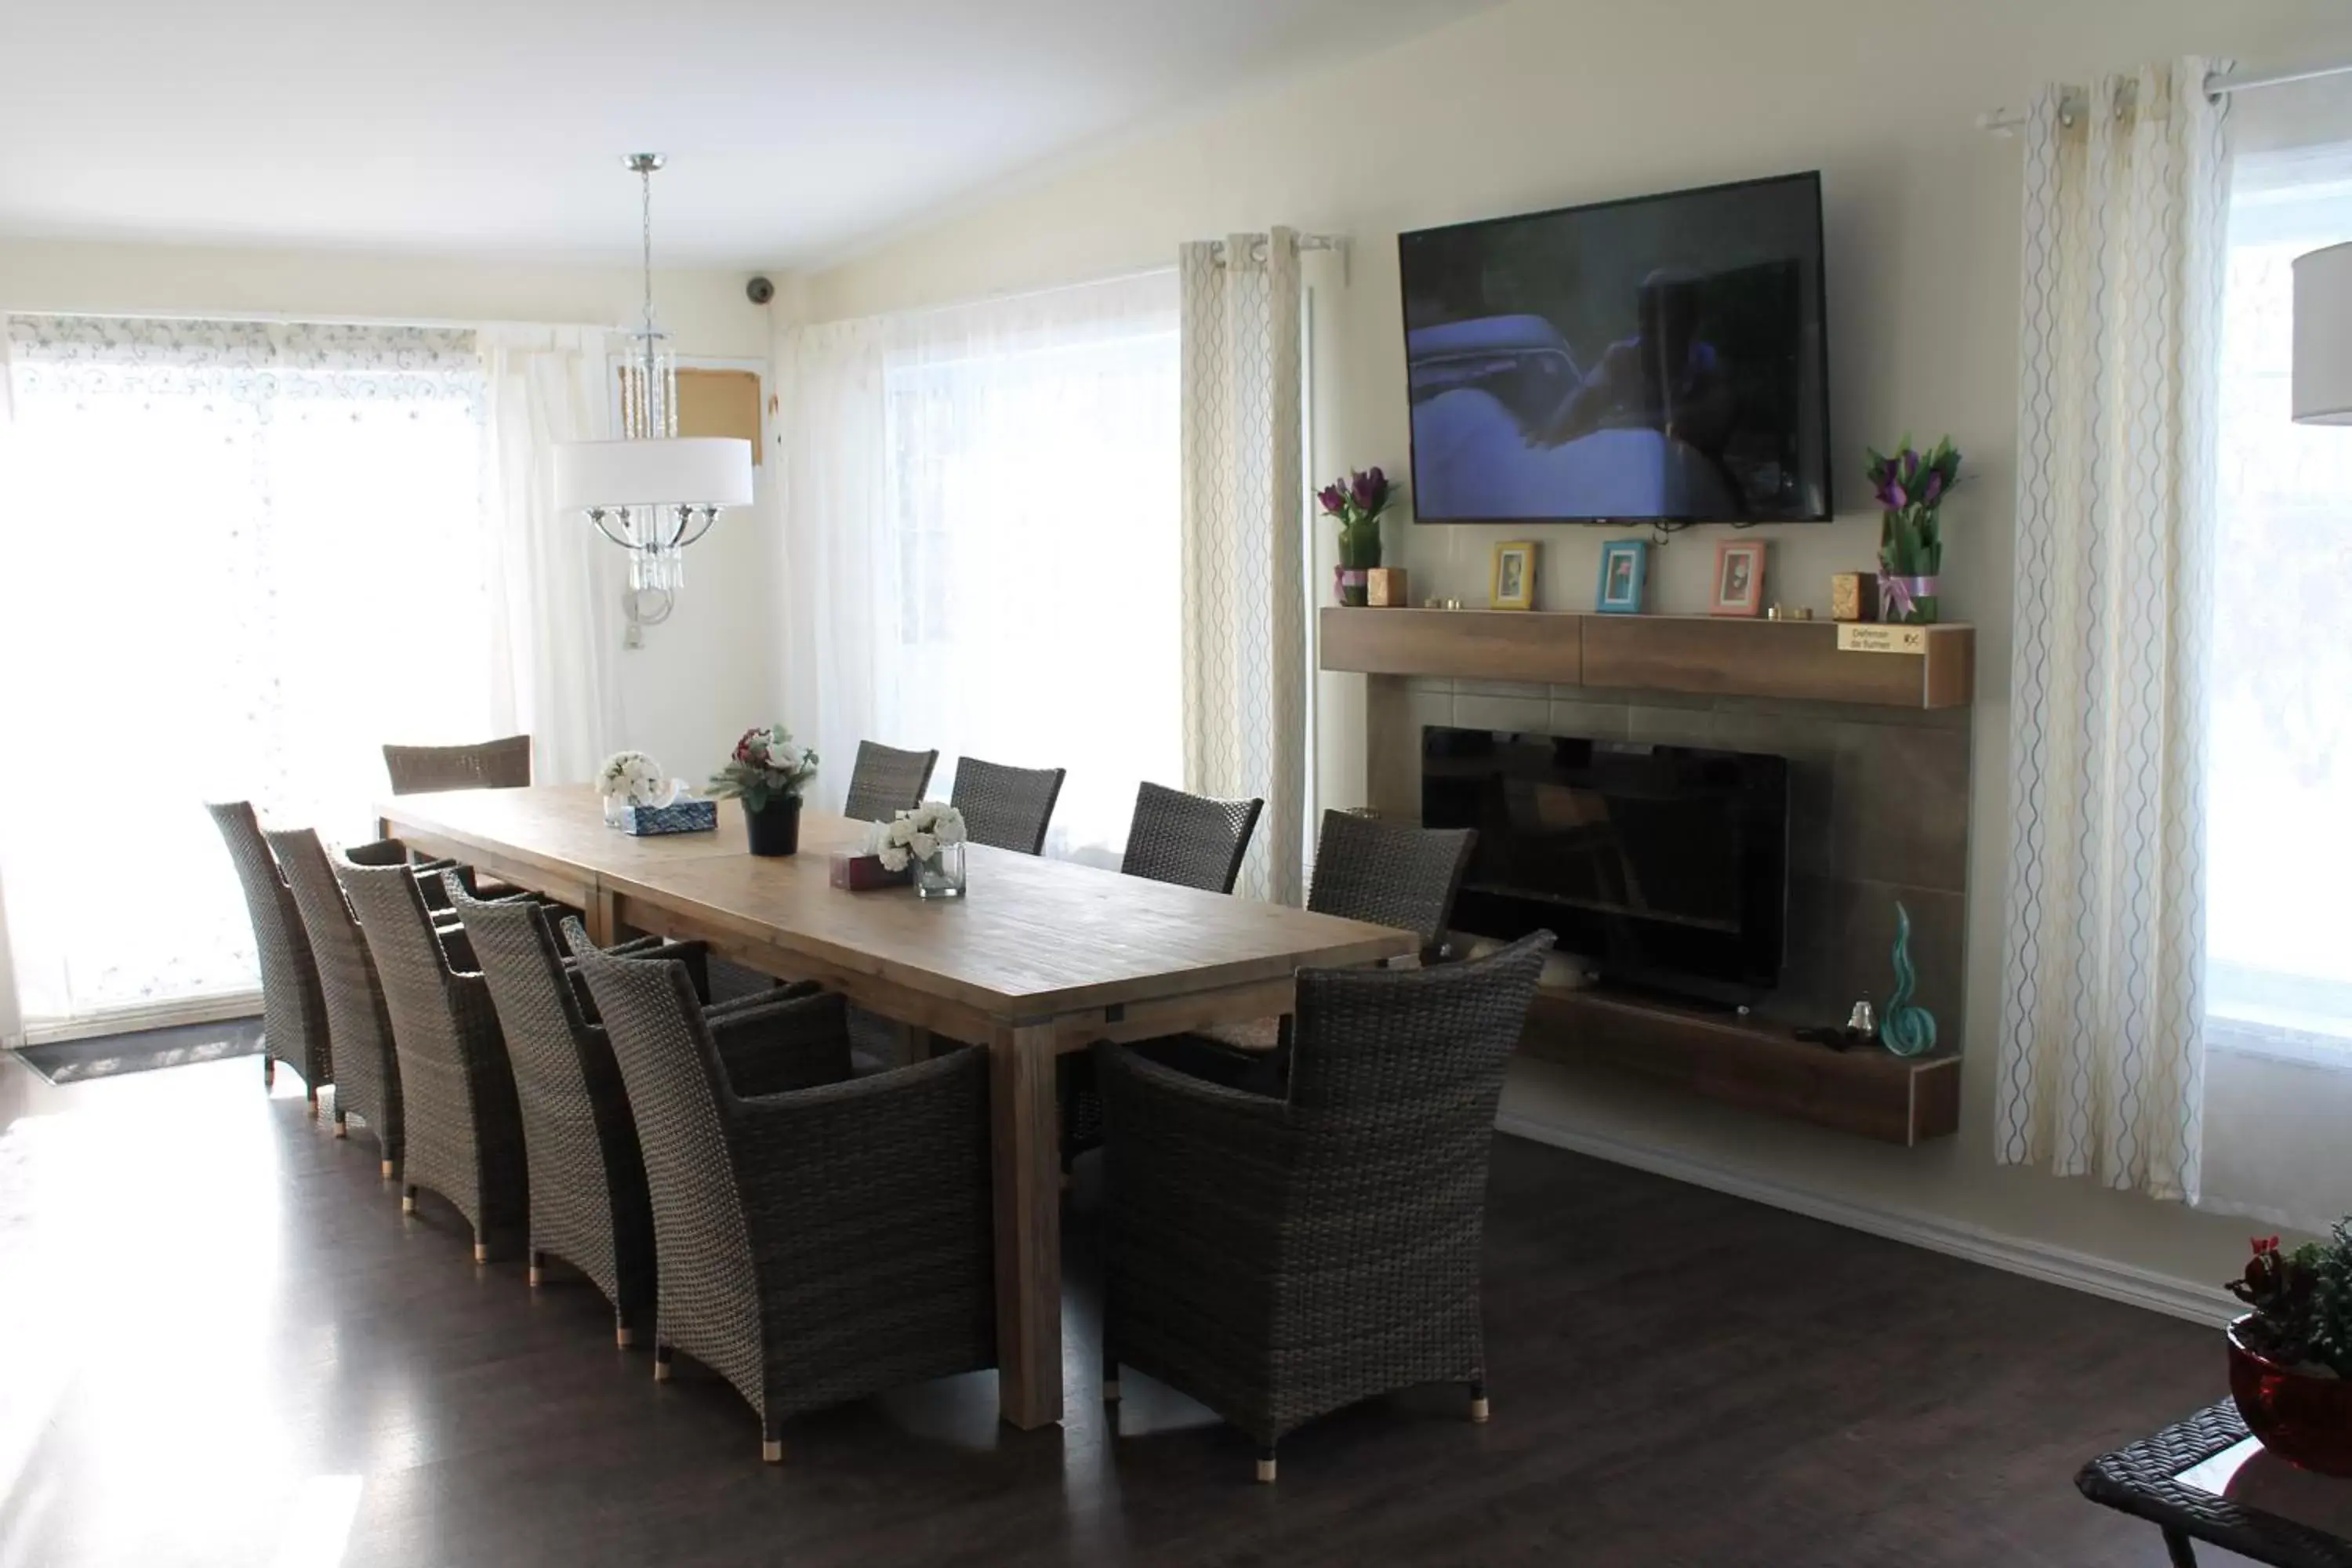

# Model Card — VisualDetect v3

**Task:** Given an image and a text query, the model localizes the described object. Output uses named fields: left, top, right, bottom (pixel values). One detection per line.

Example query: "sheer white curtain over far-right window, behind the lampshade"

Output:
left=2199, top=146, right=2352, bottom=1232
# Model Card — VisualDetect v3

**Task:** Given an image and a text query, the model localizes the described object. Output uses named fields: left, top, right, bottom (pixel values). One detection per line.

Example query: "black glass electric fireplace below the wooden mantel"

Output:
left=1421, top=724, right=1788, bottom=1001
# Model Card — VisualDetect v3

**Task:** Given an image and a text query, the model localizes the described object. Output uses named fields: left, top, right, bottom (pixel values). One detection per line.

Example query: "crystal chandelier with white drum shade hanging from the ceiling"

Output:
left=555, top=153, right=753, bottom=630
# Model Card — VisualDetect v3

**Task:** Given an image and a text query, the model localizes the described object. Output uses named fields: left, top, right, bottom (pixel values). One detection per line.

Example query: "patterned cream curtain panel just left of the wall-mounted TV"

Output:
left=1178, top=228, right=1308, bottom=902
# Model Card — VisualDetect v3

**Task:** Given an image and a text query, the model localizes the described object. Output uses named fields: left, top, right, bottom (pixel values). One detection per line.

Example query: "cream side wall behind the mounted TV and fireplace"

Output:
left=800, top=0, right=2352, bottom=1302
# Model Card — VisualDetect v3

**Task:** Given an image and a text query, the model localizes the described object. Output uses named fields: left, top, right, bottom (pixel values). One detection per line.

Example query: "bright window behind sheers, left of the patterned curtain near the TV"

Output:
left=875, top=285, right=1183, bottom=862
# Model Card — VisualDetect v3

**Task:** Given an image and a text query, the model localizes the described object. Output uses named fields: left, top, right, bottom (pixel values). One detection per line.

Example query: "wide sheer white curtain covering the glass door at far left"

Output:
left=0, top=318, right=499, bottom=1027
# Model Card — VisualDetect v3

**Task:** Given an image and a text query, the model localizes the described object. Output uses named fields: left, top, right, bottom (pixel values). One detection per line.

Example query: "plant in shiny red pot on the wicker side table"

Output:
left=2230, top=1218, right=2352, bottom=1476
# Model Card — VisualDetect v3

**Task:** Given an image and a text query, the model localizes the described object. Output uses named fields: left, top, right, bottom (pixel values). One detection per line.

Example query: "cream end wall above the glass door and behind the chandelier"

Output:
left=0, top=238, right=774, bottom=781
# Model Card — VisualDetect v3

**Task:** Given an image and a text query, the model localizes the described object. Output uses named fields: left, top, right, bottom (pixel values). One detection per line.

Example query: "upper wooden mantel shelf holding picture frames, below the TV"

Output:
left=1322, top=607, right=1976, bottom=708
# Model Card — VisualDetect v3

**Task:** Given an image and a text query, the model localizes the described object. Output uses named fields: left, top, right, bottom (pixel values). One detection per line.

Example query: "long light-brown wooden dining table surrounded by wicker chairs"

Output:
left=379, top=785, right=1416, bottom=1427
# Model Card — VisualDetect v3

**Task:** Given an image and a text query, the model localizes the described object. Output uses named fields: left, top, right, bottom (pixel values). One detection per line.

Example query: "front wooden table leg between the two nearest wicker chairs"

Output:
left=988, top=1025, right=1061, bottom=1427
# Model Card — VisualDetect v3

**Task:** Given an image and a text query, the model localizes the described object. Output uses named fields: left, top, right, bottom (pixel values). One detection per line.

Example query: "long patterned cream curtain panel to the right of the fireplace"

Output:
left=1997, top=59, right=2230, bottom=1199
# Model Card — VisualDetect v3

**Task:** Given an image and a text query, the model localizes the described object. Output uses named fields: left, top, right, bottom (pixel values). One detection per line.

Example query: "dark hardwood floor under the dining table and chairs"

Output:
left=0, top=1053, right=2227, bottom=1568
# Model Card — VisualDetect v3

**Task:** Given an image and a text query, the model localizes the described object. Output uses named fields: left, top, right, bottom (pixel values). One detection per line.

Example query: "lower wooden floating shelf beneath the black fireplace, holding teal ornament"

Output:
left=1519, top=989, right=1959, bottom=1145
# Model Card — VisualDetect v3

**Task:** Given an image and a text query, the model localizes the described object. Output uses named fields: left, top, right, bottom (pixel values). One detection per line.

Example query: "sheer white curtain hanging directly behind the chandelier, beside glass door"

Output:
left=475, top=325, right=621, bottom=783
